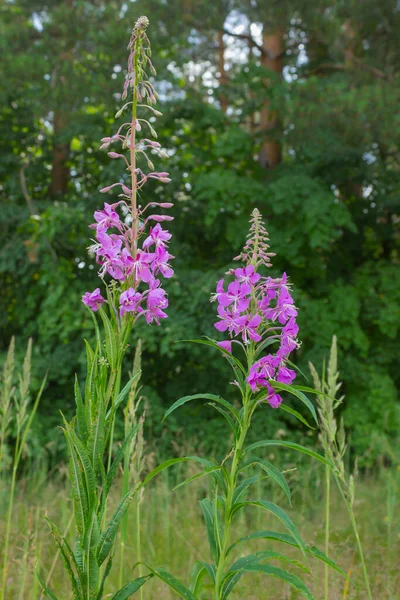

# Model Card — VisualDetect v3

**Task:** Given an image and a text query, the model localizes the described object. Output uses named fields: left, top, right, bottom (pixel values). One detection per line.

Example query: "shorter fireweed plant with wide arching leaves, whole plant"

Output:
left=164, top=209, right=344, bottom=600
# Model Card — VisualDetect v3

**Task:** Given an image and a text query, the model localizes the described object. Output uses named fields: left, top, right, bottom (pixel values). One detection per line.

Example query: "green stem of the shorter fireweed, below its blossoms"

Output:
left=215, top=398, right=250, bottom=600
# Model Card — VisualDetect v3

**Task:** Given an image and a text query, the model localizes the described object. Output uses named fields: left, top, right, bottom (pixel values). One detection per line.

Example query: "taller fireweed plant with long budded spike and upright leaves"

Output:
left=39, top=17, right=173, bottom=600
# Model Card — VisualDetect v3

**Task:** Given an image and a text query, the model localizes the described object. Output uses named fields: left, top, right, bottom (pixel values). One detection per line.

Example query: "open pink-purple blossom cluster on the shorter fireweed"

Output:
left=212, top=264, right=299, bottom=408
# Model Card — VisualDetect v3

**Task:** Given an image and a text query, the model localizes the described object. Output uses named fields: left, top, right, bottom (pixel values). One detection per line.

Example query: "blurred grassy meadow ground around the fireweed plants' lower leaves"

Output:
left=0, top=469, right=400, bottom=600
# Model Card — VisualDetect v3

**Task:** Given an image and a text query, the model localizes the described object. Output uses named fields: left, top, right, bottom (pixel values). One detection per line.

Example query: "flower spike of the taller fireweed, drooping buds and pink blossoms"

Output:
left=82, top=17, right=174, bottom=324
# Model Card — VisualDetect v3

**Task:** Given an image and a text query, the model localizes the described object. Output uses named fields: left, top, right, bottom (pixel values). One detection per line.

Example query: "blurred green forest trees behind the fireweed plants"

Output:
left=0, top=0, right=400, bottom=467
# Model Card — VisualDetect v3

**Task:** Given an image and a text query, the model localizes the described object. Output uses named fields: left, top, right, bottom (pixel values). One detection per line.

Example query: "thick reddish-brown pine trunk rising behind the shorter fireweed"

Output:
left=258, top=30, right=283, bottom=169
